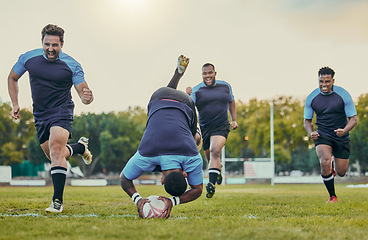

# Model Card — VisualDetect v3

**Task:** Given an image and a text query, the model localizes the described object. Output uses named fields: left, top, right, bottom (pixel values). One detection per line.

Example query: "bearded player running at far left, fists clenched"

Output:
left=8, top=24, right=93, bottom=213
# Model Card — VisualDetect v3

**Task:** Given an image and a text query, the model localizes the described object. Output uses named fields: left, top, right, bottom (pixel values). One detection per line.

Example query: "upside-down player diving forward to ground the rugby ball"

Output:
left=120, top=56, right=203, bottom=218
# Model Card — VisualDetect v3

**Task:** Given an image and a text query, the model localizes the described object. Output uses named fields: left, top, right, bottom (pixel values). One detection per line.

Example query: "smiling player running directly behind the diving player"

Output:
left=186, top=63, right=238, bottom=198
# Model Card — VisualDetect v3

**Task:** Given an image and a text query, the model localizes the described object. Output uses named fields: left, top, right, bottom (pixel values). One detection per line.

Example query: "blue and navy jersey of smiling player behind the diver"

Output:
left=190, top=80, right=234, bottom=128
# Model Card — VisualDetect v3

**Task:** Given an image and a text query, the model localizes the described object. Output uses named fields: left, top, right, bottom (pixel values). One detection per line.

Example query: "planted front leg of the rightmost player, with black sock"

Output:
left=316, top=144, right=336, bottom=199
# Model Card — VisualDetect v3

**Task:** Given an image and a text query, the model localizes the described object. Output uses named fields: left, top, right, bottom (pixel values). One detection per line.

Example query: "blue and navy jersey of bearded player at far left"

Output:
left=13, top=48, right=85, bottom=120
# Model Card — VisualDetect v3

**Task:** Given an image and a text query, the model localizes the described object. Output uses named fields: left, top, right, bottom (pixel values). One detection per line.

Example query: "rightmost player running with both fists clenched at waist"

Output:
left=304, top=67, right=357, bottom=202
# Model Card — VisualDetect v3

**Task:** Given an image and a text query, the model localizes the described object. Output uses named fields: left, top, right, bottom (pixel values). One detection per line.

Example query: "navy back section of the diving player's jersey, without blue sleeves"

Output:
left=138, top=93, right=198, bottom=157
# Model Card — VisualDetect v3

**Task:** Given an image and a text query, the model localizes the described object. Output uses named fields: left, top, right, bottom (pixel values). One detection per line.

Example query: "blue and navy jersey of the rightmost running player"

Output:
left=304, top=85, right=357, bottom=140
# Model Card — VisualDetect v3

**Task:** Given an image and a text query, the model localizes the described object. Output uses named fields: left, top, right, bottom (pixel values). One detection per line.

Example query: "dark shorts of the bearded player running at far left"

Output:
left=35, top=118, right=73, bottom=144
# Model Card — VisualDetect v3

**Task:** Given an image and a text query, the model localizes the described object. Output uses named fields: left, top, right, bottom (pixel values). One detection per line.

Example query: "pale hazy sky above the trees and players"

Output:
left=0, top=0, right=368, bottom=114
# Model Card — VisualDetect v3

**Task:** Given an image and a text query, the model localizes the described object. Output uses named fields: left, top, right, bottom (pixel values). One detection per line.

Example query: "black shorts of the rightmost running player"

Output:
left=314, top=136, right=350, bottom=159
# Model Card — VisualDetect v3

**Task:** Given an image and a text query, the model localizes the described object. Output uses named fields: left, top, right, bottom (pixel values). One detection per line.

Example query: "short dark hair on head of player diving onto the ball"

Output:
left=164, top=171, right=187, bottom=196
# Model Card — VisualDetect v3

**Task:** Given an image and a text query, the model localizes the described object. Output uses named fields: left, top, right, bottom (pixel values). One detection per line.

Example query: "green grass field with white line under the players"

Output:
left=0, top=184, right=368, bottom=240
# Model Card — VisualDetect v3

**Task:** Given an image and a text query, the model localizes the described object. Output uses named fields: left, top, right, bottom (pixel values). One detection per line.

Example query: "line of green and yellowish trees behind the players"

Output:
left=0, top=94, right=368, bottom=176
